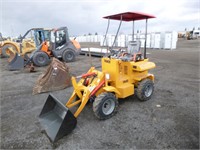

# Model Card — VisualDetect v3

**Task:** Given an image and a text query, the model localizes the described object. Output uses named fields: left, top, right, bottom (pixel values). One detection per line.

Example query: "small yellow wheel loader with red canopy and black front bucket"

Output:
left=39, top=12, right=155, bottom=142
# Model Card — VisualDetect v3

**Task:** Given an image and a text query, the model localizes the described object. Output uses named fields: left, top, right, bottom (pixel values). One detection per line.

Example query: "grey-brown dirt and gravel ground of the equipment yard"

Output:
left=0, top=40, right=200, bottom=149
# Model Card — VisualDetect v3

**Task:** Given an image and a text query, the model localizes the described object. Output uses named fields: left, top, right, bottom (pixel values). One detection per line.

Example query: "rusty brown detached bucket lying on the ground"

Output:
left=33, top=58, right=71, bottom=94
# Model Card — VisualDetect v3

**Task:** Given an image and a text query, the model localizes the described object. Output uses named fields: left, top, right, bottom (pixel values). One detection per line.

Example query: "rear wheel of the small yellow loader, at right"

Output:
left=135, top=79, right=154, bottom=101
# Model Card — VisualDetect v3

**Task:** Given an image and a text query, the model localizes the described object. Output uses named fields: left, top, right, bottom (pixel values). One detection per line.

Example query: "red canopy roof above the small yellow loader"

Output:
left=103, top=12, right=156, bottom=21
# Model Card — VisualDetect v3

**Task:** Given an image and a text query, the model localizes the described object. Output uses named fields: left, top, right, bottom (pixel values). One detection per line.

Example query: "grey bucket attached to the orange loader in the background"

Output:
left=8, top=53, right=24, bottom=71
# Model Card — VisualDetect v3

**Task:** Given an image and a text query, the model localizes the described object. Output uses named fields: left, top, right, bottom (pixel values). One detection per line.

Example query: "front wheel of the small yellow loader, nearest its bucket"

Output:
left=93, top=92, right=118, bottom=120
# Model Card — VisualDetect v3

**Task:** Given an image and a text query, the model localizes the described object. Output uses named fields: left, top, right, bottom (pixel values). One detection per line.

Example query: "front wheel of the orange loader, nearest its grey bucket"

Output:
left=33, top=52, right=50, bottom=67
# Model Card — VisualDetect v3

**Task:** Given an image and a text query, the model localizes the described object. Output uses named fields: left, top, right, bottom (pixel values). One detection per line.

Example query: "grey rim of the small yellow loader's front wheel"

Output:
left=102, top=99, right=115, bottom=115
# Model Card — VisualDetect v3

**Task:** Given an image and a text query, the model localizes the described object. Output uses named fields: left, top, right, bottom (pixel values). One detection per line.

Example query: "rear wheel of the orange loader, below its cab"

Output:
left=62, top=48, right=76, bottom=62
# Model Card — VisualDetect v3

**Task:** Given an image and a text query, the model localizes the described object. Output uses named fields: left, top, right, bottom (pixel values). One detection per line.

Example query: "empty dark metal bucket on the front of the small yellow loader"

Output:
left=39, top=94, right=77, bottom=142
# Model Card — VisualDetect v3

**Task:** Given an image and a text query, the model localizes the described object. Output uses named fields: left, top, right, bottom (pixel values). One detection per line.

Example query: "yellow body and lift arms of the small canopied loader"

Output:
left=66, top=58, right=156, bottom=117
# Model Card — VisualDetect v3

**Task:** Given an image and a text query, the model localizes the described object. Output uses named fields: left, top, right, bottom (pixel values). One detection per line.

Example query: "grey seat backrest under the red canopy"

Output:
left=127, top=41, right=141, bottom=55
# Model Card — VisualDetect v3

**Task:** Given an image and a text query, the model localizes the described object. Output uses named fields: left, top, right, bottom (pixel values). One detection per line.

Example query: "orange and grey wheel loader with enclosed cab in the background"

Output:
left=9, top=27, right=81, bottom=70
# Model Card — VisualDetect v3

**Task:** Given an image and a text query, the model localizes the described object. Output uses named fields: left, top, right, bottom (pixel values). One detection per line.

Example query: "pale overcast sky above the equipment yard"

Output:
left=0, top=0, right=200, bottom=37
